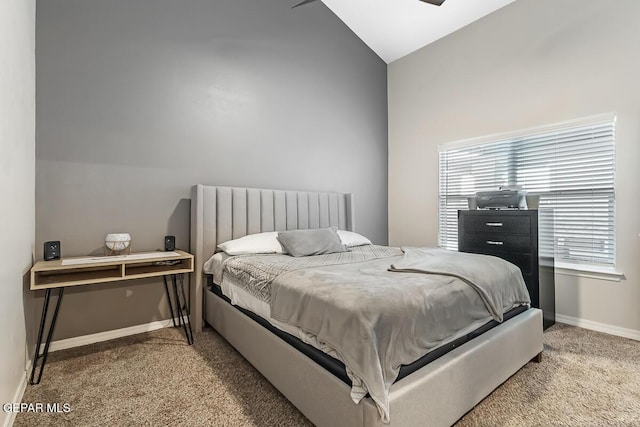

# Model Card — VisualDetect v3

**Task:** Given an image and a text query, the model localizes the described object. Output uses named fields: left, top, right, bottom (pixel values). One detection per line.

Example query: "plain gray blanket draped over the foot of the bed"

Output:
left=270, top=248, right=530, bottom=422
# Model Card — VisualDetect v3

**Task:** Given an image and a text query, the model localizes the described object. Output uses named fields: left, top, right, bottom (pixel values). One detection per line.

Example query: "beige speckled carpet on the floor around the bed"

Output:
left=15, top=325, right=640, bottom=427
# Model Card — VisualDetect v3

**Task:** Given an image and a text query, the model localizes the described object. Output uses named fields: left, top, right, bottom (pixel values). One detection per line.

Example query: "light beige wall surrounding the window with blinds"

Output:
left=388, top=0, right=640, bottom=338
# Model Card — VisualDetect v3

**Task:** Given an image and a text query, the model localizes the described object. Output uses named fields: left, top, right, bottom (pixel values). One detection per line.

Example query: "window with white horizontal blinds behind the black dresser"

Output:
left=439, top=114, right=615, bottom=267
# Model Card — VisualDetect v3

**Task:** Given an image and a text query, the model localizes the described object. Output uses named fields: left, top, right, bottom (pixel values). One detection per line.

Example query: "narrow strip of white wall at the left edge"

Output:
left=0, top=0, right=35, bottom=425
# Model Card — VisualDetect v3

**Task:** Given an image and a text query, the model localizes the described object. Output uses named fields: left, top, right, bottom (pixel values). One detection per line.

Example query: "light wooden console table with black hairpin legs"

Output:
left=29, top=250, right=193, bottom=384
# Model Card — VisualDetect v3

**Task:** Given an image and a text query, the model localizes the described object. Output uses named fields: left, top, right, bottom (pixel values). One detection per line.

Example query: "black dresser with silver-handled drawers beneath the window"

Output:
left=458, top=209, right=556, bottom=329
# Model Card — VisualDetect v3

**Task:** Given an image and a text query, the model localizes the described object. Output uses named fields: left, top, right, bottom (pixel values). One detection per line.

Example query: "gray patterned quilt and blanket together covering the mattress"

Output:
left=207, top=245, right=529, bottom=420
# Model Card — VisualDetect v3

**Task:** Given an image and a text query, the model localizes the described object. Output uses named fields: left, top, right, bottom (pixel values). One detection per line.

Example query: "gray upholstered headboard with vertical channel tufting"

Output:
left=190, top=184, right=354, bottom=331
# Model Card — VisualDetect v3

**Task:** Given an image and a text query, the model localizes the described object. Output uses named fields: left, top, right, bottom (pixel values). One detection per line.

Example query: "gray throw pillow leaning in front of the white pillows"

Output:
left=278, top=227, right=347, bottom=257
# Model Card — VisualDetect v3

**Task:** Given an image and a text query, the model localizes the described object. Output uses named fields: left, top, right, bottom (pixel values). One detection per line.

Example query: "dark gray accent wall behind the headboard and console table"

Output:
left=35, top=0, right=387, bottom=340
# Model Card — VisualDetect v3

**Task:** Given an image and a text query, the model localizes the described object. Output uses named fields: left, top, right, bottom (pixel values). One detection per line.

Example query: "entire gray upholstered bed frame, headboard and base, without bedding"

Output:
left=191, top=185, right=542, bottom=426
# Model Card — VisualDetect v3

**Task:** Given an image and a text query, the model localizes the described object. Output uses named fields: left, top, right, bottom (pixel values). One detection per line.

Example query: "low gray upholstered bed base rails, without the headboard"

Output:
left=205, top=290, right=542, bottom=427
